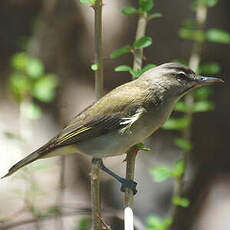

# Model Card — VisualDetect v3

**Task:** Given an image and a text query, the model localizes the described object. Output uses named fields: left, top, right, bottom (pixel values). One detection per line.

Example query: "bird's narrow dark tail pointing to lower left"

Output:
left=1, top=151, right=40, bottom=179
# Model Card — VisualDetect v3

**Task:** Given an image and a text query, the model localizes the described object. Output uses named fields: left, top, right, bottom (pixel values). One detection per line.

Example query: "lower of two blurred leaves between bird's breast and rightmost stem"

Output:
left=162, top=117, right=190, bottom=130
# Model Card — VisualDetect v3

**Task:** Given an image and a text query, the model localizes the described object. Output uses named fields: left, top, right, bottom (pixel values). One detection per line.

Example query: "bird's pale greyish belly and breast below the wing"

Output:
left=76, top=100, right=173, bottom=158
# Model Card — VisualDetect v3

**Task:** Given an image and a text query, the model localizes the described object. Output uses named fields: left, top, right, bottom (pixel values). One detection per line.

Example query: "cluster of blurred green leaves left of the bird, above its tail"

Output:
left=9, top=52, right=58, bottom=119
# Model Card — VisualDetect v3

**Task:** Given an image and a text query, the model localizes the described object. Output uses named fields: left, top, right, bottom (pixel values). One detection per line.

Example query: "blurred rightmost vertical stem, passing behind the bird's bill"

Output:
left=170, top=5, right=207, bottom=226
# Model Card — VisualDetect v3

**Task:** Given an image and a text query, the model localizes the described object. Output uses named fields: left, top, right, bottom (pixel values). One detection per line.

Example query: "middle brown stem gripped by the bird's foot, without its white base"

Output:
left=124, top=13, right=148, bottom=208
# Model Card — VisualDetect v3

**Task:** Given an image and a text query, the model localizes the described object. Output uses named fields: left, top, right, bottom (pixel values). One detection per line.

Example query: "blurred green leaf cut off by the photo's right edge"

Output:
left=206, top=29, right=230, bottom=44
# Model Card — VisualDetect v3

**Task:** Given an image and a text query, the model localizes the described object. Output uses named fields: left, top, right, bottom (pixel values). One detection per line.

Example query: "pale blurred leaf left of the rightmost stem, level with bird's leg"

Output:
left=150, top=166, right=172, bottom=182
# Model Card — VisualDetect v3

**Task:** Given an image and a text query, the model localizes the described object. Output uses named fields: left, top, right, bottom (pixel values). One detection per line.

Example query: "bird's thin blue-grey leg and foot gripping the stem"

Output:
left=92, top=158, right=137, bottom=195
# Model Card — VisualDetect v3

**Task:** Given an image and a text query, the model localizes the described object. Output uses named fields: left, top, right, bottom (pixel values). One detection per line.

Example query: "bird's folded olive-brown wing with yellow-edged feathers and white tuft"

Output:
left=55, top=82, right=144, bottom=147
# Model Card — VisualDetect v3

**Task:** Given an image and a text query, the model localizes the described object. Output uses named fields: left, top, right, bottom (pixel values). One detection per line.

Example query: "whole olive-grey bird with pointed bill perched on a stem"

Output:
left=2, top=63, right=223, bottom=194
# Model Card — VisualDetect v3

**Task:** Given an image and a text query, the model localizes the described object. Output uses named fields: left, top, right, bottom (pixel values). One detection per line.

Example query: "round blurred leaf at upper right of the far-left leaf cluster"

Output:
left=26, top=58, right=44, bottom=78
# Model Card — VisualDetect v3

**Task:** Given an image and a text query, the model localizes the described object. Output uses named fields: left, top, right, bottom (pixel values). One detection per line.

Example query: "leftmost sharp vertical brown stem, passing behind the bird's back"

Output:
left=91, top=0, right=104, bottom=230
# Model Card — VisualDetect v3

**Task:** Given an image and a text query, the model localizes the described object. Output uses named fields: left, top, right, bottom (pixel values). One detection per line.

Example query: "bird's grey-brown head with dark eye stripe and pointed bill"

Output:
left=143, top=63, right=224, bottom=98
